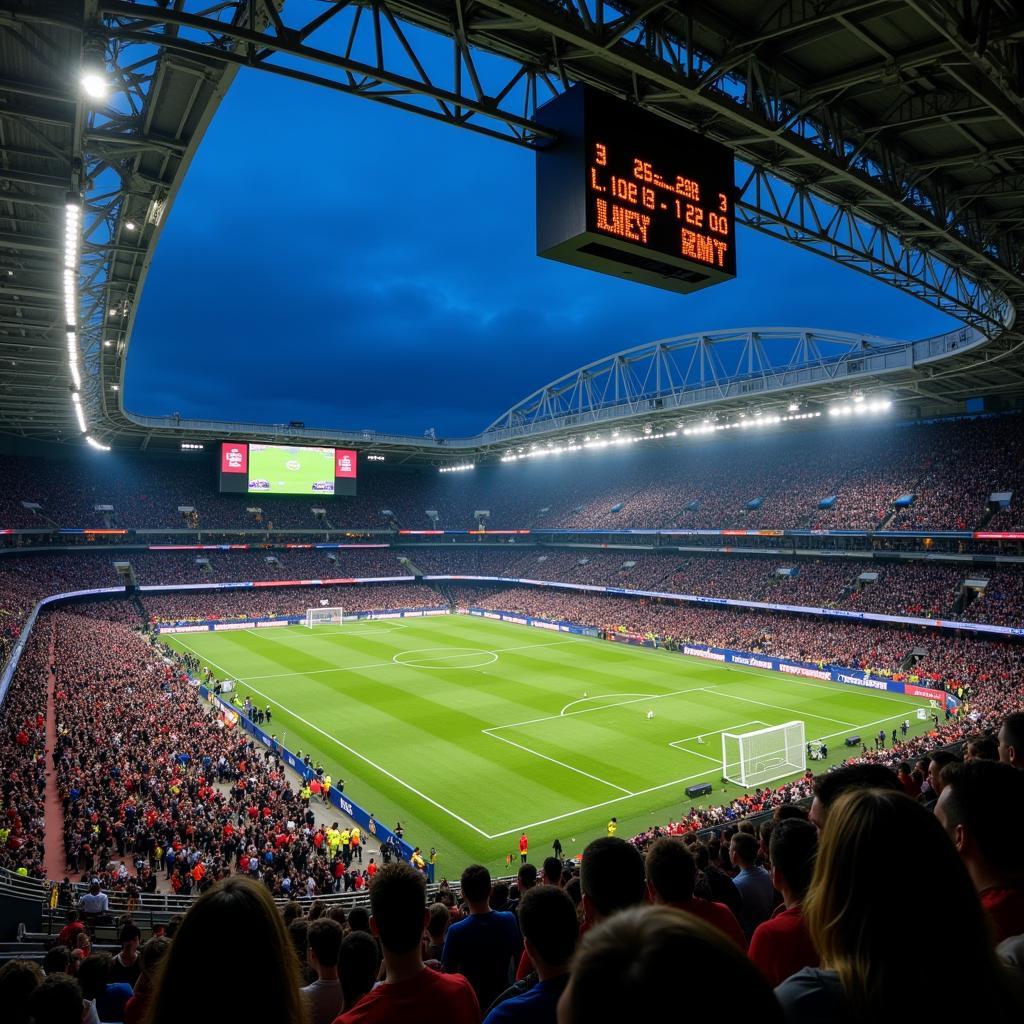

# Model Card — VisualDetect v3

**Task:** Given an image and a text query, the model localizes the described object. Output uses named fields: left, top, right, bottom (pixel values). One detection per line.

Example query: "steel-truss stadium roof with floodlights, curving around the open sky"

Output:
left=0, top=0, right=1024, bottom=458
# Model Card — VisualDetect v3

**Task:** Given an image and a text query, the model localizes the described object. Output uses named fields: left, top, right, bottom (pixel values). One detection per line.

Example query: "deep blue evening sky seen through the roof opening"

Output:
left=125, top=62, right=956, bottom=436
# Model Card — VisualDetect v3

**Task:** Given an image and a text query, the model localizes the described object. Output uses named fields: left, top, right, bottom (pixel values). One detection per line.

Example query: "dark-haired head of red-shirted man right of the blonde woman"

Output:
left=935, top=760, right=1024, bottom=876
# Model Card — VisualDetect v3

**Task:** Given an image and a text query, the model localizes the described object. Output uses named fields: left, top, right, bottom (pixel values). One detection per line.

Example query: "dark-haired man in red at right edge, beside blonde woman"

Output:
left=935, top=759, right=1024, bottom=942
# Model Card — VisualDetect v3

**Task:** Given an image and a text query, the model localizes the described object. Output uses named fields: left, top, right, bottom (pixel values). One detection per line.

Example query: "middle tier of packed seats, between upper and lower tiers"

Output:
left=0, top=544, right=1024, bottom=665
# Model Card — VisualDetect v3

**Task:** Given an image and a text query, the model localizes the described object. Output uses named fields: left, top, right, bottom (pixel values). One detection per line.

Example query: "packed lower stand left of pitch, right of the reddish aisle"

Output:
left=45, top=612, right=399, bottom=897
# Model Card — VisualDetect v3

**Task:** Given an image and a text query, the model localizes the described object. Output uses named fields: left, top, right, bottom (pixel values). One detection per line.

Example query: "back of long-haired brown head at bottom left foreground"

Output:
left=148, top=874, right=305, bottom=1024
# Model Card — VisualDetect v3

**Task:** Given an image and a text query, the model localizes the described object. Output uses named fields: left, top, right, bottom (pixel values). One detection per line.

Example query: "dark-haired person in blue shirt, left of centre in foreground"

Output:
left=441, top=864, right=522, bottom=1007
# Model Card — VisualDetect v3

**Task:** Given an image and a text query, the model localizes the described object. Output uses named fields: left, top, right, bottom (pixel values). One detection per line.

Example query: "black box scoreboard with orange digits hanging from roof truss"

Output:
left=537, top=85, right=736, bottom=292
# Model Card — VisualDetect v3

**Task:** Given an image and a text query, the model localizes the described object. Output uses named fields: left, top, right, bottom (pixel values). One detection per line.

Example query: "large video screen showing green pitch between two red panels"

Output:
left=220, top=441, right=357, bottom=498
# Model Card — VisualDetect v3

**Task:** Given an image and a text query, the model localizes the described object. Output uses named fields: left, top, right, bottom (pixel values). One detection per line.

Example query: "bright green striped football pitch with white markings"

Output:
left=164, top=615, right=931, bottom=877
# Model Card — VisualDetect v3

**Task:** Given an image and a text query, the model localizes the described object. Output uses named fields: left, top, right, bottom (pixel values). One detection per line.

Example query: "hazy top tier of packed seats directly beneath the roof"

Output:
left=0, top=416, right=1024, bottom=530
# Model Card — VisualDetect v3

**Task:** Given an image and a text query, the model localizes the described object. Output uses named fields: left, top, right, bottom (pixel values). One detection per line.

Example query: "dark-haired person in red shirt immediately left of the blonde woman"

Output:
left=750, top=818, right=818, bottom=987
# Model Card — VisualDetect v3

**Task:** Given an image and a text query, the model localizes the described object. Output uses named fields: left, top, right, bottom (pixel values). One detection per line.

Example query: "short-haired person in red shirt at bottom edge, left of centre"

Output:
left=335, top=861, right=480, bottom=1024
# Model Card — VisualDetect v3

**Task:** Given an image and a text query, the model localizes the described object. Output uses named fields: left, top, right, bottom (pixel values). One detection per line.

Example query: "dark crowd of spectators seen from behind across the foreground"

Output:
left=0, top=745, right=1024, bottom=1024
